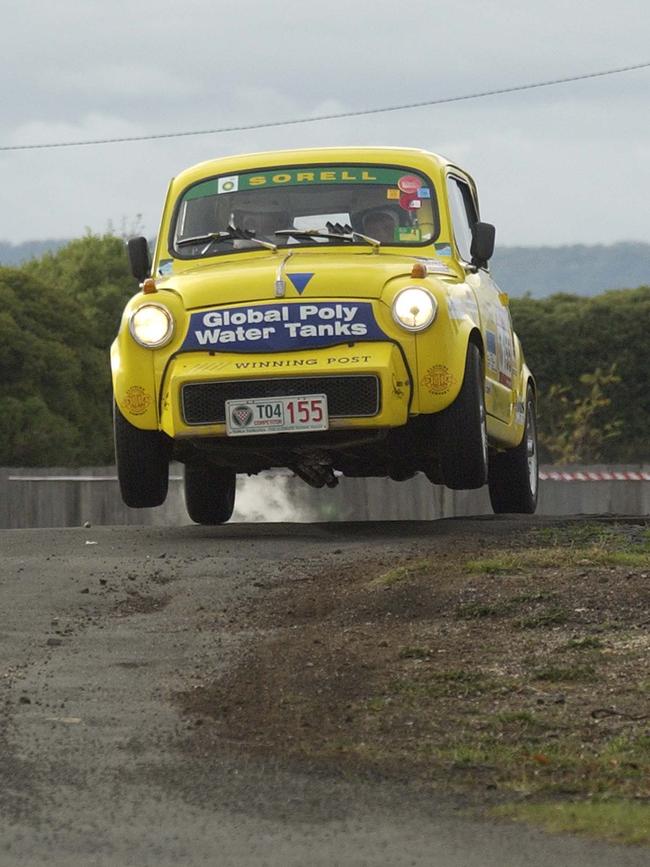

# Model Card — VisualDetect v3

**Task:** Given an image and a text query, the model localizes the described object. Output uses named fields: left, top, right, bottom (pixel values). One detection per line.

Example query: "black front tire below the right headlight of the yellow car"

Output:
left=439, top=343, right=488, bottom=490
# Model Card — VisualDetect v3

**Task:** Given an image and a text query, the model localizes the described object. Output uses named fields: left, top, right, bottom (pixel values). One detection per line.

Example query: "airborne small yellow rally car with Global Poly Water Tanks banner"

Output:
left=111, top=148, right=537, bottom=524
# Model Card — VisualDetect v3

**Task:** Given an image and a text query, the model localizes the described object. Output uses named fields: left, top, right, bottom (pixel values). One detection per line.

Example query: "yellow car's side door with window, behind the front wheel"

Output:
left=447, top=168, right=515, bottom=423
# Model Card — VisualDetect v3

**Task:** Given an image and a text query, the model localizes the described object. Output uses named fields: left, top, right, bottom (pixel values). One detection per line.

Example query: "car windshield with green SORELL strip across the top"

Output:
left=171, top=165, right=439, bottom=259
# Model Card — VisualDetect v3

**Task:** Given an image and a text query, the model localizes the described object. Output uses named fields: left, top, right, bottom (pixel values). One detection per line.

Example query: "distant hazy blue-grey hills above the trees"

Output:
left=0, top=240, right=650, bottom=298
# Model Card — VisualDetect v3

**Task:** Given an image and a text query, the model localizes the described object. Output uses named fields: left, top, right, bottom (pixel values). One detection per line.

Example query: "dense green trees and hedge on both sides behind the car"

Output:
left=0, top=234, right=650, bottom=467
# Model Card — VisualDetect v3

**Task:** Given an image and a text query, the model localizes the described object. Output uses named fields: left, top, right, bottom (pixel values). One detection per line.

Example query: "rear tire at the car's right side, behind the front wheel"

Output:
left=488, top=386, right=539, bottom=515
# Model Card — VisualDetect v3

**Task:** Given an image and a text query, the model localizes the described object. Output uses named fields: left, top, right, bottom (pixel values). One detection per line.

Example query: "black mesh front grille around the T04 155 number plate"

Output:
left=181, top=376, right=380, bottom=424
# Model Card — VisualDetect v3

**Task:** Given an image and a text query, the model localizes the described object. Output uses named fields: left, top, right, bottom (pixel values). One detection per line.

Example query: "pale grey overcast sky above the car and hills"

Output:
left=0, top=0, right=650, bottom=245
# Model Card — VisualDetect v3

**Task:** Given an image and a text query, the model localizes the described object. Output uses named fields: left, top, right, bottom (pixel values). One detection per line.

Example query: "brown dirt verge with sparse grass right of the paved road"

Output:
left=178, top=522, right=650, bottom=841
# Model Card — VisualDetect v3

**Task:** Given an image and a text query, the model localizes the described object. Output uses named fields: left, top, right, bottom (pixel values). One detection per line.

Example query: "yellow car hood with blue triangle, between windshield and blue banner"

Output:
left=156, top=248, right=459, bottom=310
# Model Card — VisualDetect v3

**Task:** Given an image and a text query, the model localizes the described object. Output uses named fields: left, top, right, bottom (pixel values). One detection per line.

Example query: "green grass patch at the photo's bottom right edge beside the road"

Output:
left=490, top=799, right=650, bottom=843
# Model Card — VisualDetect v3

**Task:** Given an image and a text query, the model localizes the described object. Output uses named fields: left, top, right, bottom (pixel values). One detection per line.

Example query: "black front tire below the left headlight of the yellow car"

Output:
left=113, top=403, right=171, bottom=509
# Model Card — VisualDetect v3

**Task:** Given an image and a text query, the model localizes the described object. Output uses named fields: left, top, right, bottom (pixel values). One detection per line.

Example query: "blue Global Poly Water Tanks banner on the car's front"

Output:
left=181, top=300, right=386, bottom=352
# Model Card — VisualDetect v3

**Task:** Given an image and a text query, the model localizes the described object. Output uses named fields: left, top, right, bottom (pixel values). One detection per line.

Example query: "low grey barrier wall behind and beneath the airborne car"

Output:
left=0, top=465, right=650, bottom=529
